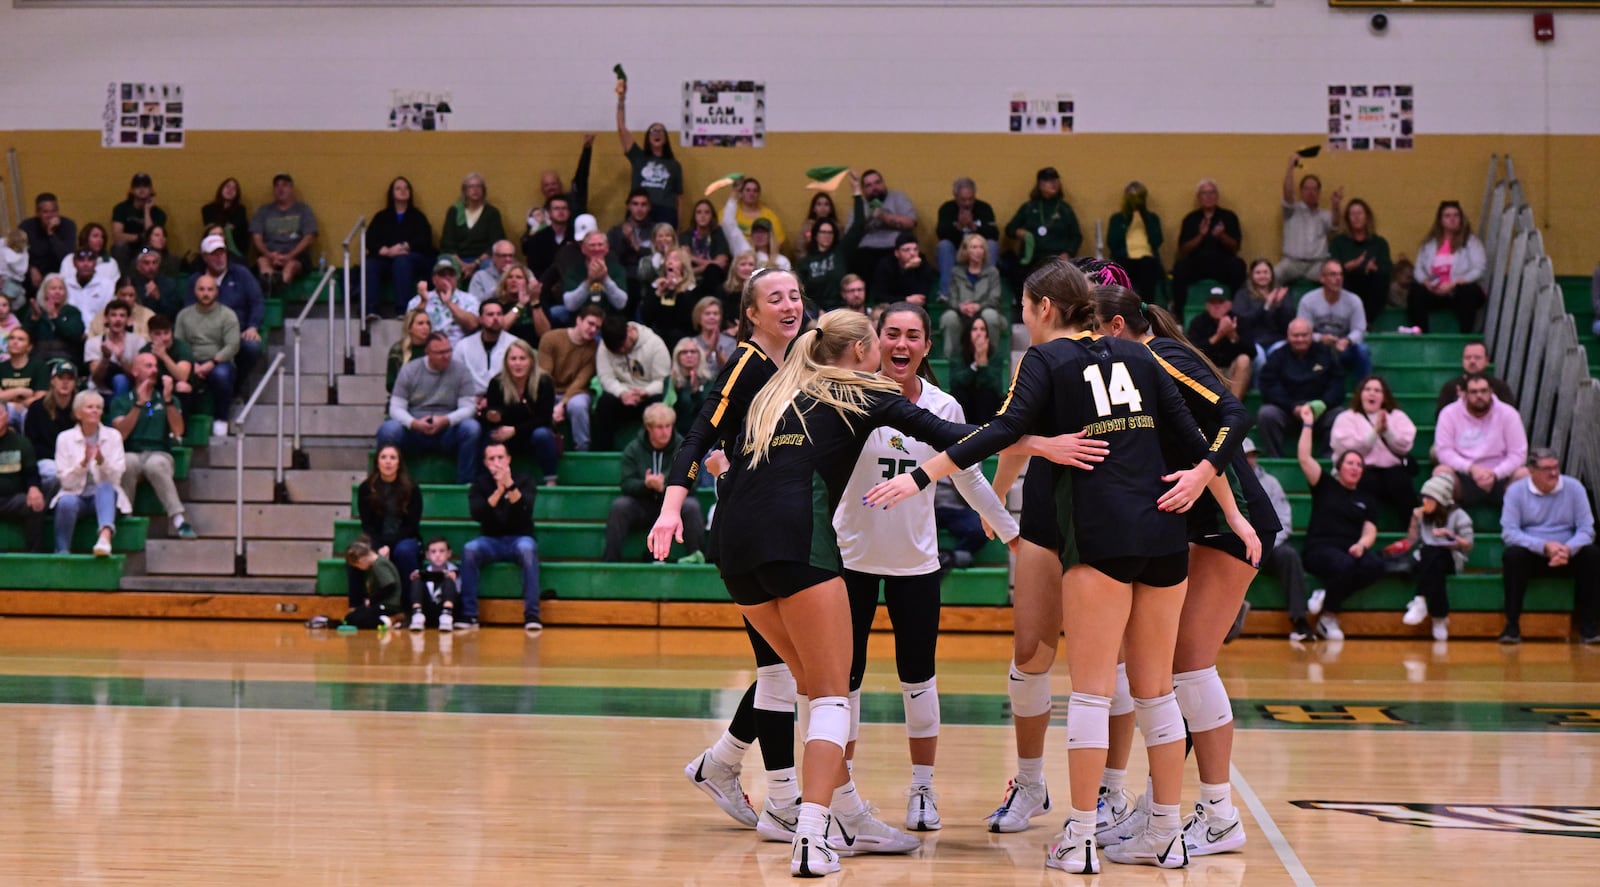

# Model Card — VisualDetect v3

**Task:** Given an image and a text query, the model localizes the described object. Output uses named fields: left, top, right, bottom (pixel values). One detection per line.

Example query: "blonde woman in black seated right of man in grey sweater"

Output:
left=482, top=336, right=562, bottom=485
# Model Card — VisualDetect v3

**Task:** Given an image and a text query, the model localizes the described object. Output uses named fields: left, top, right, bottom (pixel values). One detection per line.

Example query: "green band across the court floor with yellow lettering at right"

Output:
left=0, top=674, right=1600, bottom=733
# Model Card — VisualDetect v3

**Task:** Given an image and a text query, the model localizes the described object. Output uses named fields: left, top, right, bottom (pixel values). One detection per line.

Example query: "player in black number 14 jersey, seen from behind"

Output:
left=867, top=263, right=1259, bottom=874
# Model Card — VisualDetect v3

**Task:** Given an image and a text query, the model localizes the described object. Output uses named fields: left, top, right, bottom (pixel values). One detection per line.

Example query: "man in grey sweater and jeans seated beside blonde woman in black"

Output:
left=378, top=330, right=478, bottom=484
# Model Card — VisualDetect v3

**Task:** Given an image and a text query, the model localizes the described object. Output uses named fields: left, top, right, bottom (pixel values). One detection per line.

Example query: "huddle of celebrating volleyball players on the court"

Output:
left=650, top=252, right=1278, bottom=877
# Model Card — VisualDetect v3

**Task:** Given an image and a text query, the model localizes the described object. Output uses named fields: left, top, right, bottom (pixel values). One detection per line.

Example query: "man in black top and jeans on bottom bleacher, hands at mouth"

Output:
left=456, top=442, right=544, bottom=632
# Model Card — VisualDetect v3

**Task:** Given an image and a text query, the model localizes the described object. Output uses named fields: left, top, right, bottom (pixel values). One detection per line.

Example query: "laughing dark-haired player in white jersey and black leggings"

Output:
left=834, top=303, right=1018, bottom=831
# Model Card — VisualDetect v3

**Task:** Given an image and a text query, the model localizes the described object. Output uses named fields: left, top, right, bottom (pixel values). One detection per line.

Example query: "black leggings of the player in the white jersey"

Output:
left=845, top=570, right=939, bottom=692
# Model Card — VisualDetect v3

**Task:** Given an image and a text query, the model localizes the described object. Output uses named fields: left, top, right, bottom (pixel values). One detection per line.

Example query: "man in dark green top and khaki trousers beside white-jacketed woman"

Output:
left=106, top=354, right=195, bottom=540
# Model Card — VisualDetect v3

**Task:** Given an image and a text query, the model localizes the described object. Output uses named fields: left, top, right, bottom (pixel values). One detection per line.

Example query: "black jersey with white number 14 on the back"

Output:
left=947, top=333, right=1210, bottom=565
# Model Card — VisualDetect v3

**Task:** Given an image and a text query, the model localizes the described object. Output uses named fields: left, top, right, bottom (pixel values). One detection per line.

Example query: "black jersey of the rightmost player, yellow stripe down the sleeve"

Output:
left=1147, top=338, right=1282, bottom=548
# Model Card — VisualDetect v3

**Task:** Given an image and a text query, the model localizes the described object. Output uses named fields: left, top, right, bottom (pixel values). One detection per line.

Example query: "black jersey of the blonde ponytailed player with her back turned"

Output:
left=717, top=384, right=976, bottom=576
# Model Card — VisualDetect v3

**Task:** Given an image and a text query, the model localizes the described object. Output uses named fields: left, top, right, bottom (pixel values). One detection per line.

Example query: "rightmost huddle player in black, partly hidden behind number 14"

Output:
left=1094, top=287, right=1280, bottom=857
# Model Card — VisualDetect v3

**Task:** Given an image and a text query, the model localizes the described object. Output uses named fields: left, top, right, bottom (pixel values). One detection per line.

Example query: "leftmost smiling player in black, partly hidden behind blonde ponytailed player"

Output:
left=650, top=269, right=805, bottom=842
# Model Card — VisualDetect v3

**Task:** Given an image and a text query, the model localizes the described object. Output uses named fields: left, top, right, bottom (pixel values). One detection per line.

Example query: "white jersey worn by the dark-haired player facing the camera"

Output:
left=834, top=379, right=1018, bottom=576
